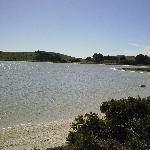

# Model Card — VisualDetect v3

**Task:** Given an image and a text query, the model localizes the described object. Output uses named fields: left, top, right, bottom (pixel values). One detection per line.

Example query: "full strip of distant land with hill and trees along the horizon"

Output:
left=0, top=50, right=150, bottom=65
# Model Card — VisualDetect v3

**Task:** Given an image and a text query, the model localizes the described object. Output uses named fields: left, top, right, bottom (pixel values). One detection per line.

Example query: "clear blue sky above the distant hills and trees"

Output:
left=0, top=0, right=150, bottom=58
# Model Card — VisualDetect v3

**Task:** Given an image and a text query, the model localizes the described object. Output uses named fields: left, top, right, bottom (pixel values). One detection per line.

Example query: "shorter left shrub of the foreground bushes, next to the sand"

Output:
left=67, top=113, right=121, bottom=150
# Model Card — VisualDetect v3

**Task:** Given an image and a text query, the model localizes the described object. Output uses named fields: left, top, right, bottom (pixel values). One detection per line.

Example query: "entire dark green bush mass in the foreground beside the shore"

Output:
left=67, top=97, right=150, bottom=150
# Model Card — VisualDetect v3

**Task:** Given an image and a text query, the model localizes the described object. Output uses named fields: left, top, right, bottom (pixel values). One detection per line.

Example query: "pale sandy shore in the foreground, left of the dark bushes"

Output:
left=0, top=119, right=73, bottom=150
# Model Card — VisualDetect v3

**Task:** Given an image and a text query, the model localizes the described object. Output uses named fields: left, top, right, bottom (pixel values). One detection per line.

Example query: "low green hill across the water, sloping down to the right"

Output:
left=0, top=50, right=82, bottom=63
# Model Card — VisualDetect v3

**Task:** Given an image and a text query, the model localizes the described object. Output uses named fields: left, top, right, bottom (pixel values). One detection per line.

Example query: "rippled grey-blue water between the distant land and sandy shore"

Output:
left=0, top=62, right=150, bottom=128
